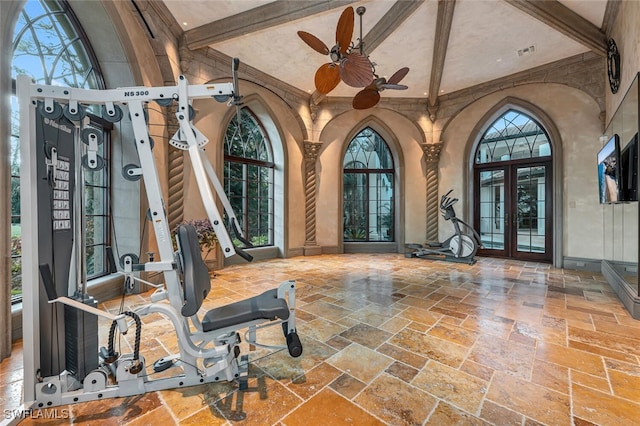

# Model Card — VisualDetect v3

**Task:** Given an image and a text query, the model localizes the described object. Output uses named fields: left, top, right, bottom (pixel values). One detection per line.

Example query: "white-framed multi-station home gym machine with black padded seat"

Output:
left=18, top=59, right=302, bottom=409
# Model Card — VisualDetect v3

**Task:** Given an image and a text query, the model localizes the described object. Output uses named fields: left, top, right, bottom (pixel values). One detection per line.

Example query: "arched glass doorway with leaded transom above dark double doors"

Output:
left=473, top=108, right=554, bottom=262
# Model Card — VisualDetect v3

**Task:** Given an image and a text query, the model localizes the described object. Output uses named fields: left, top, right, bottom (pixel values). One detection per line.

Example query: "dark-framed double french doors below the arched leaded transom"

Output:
left=474, top=160, right=553, bottom=262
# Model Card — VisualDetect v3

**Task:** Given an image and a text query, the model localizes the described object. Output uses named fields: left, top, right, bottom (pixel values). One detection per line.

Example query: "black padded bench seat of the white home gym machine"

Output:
left=202, top=289, right=289, bottom=331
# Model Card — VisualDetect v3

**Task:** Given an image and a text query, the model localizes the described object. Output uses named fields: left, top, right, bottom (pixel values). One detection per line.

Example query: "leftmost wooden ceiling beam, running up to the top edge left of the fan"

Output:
left=185, top=0, right=357, bottom=50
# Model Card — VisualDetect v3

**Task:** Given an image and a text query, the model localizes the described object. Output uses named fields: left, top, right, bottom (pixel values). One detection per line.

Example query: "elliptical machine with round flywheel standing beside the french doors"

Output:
left=405, top=189, right=482, bottom=265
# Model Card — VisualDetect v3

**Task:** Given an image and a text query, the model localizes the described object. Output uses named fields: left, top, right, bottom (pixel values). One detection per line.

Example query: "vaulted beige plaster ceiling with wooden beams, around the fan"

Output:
left=164, top=0, right=619, bottom=104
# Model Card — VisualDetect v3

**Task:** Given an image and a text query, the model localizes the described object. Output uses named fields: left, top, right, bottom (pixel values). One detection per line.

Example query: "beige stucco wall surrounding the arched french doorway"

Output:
left=439, top=84, right=602, bottom=259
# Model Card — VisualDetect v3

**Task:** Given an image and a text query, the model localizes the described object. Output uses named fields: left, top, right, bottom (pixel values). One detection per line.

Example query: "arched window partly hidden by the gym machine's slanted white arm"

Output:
left=224, top=107, right=274, bottom=247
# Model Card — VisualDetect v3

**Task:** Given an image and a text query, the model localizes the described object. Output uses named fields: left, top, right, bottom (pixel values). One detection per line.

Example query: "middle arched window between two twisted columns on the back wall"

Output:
left=343, top=127, right=394, bottom=242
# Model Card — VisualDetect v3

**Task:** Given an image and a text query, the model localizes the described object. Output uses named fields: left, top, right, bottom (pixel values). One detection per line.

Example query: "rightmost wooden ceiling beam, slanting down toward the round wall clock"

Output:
left=505, top=0, right=607, bottom=56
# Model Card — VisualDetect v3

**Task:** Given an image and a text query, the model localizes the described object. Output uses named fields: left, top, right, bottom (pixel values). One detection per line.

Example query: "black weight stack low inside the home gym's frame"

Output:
left=64, top=294, right=98, bottom=382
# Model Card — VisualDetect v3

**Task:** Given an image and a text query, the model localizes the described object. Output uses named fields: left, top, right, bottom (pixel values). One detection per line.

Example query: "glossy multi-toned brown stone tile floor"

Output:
left=0, top=254, right=640, bottom=426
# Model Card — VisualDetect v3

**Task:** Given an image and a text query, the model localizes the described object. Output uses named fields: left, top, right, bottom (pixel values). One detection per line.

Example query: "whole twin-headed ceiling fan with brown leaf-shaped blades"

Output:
left=298, top=6, right=409, bottom=109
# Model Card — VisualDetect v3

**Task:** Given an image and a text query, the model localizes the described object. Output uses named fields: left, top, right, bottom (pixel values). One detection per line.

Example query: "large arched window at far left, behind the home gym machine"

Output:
left=10, top=0, right=109, bottom=299
